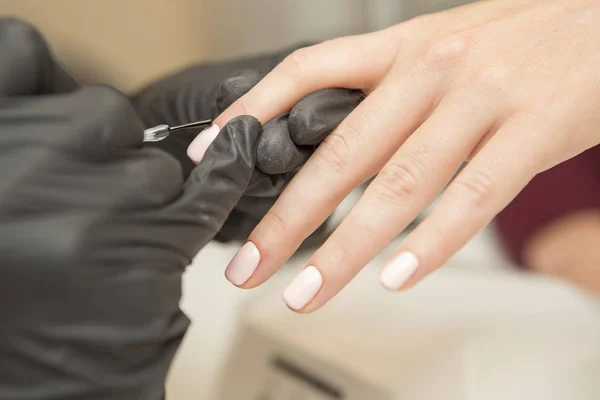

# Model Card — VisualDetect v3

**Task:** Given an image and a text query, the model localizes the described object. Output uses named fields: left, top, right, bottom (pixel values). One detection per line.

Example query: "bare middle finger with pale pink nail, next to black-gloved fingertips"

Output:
left=226, top=67, right=439, bottom=288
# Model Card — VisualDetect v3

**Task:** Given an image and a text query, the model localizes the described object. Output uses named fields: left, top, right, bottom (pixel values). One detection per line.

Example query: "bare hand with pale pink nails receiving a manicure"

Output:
left=216, top=0, right=600, bottom=312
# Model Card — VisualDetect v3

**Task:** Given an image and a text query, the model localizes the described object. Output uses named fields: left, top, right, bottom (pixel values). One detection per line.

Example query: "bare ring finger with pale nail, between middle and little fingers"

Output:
left=284, top=90, right=497, bottom=312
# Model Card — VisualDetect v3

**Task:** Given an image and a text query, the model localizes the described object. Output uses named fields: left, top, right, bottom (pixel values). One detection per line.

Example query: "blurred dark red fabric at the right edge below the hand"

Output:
left=496, top=146, right=600, bottom=264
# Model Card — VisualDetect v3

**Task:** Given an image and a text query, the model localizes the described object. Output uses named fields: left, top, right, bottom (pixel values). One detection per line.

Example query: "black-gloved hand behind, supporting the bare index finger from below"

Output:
left=134, top=56, right=364, bottom=241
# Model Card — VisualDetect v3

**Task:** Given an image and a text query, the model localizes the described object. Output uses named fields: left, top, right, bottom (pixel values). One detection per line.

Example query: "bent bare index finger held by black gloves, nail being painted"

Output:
left=215, top=29, right=398, bottom=126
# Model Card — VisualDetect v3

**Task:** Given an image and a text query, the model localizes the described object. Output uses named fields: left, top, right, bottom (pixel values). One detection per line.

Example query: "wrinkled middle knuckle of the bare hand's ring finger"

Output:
left=374, top=161, right=420, bottom=204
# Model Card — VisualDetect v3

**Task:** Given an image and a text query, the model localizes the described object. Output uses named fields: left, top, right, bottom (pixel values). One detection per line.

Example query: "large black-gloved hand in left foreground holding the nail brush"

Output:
left=0, top=20, right=261, bottom=400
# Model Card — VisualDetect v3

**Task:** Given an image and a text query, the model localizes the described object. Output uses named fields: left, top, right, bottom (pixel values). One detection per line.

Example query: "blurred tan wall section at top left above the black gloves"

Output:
left=0, top=0, right=214, bottom=91
